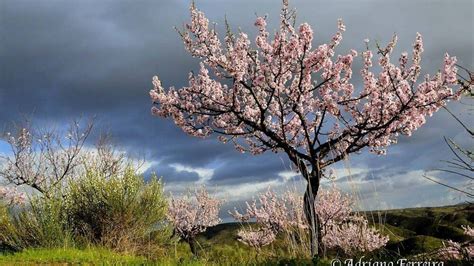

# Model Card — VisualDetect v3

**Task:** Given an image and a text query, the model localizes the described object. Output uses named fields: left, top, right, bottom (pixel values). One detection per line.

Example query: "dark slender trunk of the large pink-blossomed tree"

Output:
left=304, top=171, right=323, bottom=257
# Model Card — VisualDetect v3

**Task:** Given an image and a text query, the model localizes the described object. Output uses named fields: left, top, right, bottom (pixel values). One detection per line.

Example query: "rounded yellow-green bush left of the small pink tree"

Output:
left=65, top=167, right=169, bottom=253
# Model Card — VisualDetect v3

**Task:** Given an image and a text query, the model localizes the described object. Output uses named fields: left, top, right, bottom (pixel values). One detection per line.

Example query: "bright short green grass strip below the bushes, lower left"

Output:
left=0, top=248, right=147, bottom=265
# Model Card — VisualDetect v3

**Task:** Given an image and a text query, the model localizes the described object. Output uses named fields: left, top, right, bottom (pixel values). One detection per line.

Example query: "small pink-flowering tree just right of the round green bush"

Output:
left=167, top=188, right=222, bottom=256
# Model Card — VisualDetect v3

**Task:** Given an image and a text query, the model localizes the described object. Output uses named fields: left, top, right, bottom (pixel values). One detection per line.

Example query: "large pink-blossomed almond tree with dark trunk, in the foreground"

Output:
left=150, top=0, right=471, bottom=254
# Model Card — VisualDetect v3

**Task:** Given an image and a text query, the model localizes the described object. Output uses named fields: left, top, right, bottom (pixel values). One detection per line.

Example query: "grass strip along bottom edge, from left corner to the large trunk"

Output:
left=0, top=244, right=330, bottom=266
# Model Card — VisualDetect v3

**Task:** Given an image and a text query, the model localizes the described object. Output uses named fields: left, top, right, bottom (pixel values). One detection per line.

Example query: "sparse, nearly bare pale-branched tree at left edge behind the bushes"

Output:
left=0, top=121, right=93, bottom=194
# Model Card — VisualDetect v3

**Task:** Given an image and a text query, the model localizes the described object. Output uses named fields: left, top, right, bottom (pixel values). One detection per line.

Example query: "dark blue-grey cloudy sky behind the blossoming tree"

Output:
left=0, top=0, right=474, bottom=214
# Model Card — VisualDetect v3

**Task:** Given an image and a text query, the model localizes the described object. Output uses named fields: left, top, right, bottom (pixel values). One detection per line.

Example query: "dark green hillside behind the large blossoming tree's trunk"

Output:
left=191, top=204, right=474, bottom=256
